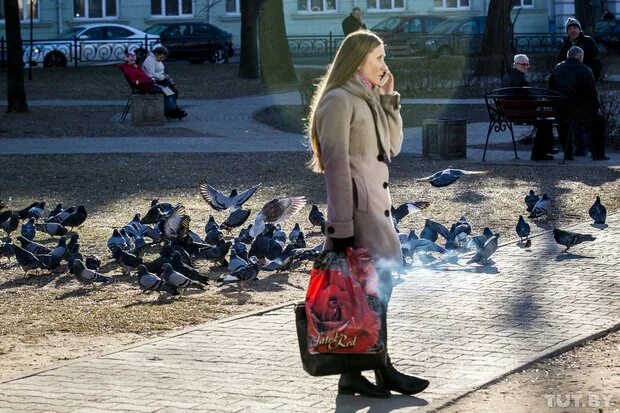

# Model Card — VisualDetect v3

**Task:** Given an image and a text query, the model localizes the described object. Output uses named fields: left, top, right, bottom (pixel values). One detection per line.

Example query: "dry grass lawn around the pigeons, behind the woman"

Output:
left=0, top=153, right=620, bottom=379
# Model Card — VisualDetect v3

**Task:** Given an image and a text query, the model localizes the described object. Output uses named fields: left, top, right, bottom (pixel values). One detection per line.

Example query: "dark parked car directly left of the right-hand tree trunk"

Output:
left=425, top=16, right=487, bottom=56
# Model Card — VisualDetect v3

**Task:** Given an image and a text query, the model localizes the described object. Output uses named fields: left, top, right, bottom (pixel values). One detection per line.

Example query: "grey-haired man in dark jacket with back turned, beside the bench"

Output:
left=549, top=46, right=608, bottom=160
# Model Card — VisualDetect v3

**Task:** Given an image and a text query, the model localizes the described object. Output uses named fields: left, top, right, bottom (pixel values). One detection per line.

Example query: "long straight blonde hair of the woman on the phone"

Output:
left=307, top=30, right=383, bottom=172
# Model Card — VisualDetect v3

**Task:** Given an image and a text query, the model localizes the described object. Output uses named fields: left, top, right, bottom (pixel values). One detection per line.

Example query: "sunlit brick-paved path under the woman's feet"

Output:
left=0, top=214, right=620, bottom=413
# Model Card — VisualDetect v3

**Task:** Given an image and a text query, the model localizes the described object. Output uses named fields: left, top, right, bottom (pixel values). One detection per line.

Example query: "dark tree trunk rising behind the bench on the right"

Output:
left=476, top=0, right=514, bottom=76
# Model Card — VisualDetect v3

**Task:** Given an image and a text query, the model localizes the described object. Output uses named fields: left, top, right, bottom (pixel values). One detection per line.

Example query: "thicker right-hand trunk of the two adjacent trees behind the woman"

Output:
left=258, top=0, right=297, bottom=84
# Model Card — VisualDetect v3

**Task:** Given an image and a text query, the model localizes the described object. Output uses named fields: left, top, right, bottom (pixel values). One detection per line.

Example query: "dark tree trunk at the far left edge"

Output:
left=4, top=0, right=28, bottom=112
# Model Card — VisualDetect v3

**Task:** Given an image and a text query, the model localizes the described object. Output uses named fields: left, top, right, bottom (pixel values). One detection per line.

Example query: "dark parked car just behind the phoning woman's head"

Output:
left=370, top=14, right=447, bottom=56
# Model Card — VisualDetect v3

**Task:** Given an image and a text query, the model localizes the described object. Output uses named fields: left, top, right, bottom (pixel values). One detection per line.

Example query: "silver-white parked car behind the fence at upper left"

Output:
left=23, top=23, right=158, bottom=67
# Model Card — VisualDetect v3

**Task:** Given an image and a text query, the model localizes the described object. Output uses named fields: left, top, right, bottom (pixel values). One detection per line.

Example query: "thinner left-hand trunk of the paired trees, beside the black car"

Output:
left=238, top=0, right=262, bottom=79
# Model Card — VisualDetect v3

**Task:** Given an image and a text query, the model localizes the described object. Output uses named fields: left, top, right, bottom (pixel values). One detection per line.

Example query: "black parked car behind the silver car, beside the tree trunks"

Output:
left=145, top=23, right=235, bottom=64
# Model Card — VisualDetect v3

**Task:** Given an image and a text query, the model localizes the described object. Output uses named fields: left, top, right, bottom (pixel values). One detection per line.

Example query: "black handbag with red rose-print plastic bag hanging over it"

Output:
left=295, top=248, right=387, bottom=376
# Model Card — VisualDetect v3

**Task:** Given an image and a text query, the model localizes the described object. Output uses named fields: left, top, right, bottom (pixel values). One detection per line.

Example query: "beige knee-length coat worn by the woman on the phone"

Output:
left=315, top=75, right=403, bottom=267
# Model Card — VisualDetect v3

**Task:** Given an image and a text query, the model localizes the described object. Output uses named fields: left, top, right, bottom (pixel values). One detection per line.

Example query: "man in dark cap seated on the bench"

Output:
left=502, top=54, right=557, bottom=161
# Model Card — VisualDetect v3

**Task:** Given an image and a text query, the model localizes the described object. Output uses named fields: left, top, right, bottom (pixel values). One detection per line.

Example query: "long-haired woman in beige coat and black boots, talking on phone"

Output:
left=308, top=30, right=429, bottom=397
